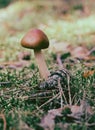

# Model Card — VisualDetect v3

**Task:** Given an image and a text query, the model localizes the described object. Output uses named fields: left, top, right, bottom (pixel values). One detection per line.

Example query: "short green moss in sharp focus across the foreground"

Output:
left=0, top=61, right=95, bottom=130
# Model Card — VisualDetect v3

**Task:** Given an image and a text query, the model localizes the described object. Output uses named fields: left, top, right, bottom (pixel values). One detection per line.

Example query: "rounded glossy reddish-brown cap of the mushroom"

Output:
left=21, top=29, right=49, bottom=50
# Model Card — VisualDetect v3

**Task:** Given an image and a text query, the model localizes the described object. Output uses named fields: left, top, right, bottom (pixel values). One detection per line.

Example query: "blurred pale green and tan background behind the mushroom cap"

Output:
left=0, top=0, right=95, bottom=62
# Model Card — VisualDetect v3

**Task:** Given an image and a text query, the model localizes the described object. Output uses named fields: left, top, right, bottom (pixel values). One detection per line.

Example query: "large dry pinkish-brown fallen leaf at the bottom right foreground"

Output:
left=39, top=100, right=94, bottom=130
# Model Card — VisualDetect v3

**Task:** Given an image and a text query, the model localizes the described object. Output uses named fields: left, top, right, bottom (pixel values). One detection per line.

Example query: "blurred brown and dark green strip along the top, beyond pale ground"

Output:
left=0, top=0, right=95, bottom=13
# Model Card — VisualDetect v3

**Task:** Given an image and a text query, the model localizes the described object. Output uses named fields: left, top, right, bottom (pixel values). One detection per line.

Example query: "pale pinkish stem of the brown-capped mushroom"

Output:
left=34, top=50, right=50, bottom=80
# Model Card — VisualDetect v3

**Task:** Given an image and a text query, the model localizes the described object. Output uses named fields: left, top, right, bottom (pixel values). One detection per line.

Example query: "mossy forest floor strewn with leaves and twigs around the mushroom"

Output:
left=0, top=1, right=95, bottom=130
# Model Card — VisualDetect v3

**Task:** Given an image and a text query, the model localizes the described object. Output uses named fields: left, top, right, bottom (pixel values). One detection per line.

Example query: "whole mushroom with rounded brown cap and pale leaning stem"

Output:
left=21, top=29, right=50, bottom=80
